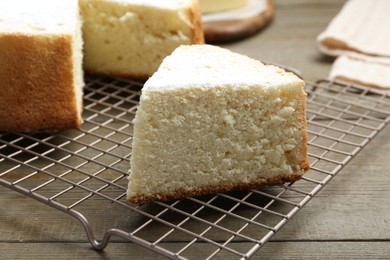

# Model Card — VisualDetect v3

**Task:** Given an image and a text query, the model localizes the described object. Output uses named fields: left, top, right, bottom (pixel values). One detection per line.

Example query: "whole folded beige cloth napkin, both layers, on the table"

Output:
left=317, top=0, right=390, bottom=90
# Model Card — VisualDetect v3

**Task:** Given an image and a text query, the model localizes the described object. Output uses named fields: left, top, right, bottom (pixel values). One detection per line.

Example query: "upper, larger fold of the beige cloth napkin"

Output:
left=317, top=0, right=390, bottom=57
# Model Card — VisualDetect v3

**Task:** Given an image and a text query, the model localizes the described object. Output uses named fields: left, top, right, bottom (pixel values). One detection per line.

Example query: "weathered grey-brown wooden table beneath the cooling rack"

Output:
left=0, top=0, right=390, bottom=259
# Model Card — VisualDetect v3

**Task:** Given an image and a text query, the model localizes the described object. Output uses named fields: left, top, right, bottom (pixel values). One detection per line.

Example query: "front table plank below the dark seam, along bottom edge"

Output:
left=0, top=241, right=390, bottom=260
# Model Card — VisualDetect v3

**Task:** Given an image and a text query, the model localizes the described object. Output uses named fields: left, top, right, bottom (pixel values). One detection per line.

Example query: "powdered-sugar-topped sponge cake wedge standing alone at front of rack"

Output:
left=127, top=45, right=309, bottom=204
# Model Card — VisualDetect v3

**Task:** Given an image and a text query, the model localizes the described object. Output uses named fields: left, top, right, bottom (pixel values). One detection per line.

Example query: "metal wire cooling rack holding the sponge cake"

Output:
left=0, top=77, right=390, bottom=259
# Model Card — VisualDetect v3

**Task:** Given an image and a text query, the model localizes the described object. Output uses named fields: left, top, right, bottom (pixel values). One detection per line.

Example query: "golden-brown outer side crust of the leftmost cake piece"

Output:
left=0, top=34, right=81, bottom=132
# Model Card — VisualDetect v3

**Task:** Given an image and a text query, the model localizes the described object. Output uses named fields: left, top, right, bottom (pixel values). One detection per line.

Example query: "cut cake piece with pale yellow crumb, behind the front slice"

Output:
left=80, top=0, right=204, bottom=80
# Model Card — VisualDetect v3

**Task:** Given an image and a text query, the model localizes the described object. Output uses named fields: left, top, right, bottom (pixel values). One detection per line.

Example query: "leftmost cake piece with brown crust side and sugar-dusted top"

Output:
left=0, top=0, right=84, bottom=132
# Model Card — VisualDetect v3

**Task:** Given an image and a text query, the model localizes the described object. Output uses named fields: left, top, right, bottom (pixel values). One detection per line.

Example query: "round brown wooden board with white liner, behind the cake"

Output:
left=202, top=0, right=275, bottom=43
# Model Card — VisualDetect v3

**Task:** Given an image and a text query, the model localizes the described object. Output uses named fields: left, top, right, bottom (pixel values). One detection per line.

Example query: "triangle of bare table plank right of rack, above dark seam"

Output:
left=274, top=126, right=390, bottom=242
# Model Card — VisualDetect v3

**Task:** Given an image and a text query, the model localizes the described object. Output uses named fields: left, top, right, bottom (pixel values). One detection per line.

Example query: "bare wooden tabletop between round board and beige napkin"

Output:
left=221, top=1, right=344, bottom=81
